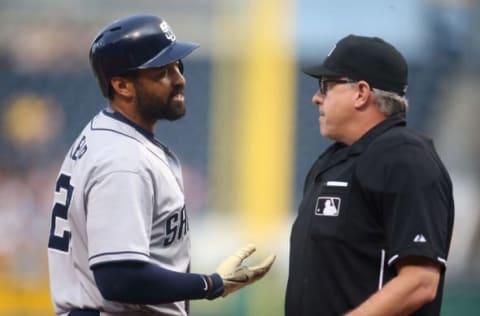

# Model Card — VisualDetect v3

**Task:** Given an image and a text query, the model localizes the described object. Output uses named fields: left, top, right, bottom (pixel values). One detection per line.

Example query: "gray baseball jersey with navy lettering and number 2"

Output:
left=48, top=109, right=190, bottom=315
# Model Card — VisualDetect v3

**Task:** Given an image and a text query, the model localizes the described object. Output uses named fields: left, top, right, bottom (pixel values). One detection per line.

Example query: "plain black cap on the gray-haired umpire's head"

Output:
left=303, top=35, right=408, bottom=96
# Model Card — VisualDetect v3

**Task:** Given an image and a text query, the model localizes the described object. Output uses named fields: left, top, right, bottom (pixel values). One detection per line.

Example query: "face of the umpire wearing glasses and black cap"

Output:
left=312, top=78, right=355, bottom=142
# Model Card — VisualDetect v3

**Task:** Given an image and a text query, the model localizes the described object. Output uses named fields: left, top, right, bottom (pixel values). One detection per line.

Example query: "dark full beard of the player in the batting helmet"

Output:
left=136, top=87, right=186, bottom=121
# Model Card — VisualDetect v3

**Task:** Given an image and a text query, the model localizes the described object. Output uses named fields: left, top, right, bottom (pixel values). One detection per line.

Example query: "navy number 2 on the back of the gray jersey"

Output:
left=48, top=173, right=73, bottom=252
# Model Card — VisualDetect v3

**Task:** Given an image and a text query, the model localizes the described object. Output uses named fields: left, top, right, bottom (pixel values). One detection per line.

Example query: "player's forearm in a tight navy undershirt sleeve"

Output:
left=93, top=262, right=221, bottom=304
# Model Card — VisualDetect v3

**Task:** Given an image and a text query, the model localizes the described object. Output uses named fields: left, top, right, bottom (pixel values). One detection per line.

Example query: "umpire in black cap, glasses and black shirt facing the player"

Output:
left=285, top=35, right=454, bottom=316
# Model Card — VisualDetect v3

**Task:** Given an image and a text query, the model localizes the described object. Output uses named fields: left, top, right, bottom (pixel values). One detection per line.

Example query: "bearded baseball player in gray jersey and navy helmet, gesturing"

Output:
left=48, top=15, right=275, bottom=316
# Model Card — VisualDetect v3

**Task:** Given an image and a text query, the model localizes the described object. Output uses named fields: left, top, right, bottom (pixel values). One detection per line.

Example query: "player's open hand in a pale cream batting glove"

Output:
left=216, top=244, right=275, bottom=297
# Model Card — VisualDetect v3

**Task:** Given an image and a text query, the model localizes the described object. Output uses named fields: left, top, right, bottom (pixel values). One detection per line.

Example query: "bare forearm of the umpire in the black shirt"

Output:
left=345, top=266, right=439, bottom=316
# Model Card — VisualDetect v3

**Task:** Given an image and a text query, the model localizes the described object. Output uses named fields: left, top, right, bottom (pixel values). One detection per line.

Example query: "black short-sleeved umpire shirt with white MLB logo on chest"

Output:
left=285, top=116, right=454, bottom=316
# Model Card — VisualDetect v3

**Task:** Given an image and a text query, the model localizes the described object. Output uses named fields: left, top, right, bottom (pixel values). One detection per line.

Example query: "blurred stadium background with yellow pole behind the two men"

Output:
left=0, top=0, right=480, bottom=316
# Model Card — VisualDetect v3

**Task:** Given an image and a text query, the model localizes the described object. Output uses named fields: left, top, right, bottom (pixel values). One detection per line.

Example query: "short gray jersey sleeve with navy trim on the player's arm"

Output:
left=87, top=171, right=154, bottom=266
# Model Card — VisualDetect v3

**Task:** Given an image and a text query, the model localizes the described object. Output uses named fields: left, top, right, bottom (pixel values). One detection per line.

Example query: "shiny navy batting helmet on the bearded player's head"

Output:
left=90, top=15, right=199, bottom=97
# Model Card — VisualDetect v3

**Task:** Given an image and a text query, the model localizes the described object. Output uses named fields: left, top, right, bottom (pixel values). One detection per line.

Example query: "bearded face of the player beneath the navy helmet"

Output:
left=134, top=63, right=186, bottom=121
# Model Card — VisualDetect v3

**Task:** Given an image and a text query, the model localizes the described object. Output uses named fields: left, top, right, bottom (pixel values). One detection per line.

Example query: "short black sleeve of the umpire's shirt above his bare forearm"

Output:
left=360, top=144, right=453, bottom=266
